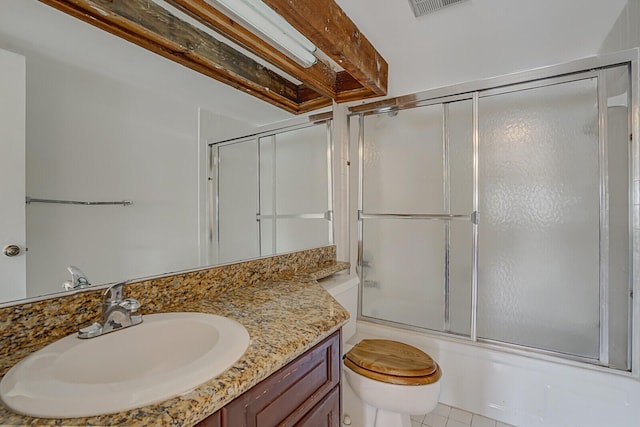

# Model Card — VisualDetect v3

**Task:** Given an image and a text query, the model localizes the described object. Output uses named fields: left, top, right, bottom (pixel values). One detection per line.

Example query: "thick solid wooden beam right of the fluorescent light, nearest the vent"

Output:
left=263, top=0, right=389, bottom=96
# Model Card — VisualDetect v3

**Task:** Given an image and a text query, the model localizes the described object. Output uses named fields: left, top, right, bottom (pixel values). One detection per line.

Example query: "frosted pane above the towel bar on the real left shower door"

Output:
left=363, top=105, right=444, bottom=213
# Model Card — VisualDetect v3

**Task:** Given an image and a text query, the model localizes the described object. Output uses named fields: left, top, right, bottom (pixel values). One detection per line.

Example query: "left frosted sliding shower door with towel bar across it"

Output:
left=360, top=99, right=472, bottom=335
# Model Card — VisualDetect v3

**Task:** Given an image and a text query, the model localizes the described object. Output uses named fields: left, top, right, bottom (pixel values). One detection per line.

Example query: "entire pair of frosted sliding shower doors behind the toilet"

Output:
left=358, top=58, right=638, bottom=371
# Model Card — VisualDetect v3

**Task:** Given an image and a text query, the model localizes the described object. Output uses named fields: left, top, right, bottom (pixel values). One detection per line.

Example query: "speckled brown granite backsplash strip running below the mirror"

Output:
left=0, top=246, right=340, bottom=376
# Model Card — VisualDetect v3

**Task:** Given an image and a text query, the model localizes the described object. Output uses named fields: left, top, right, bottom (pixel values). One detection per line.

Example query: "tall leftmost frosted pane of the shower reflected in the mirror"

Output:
left=218, top=141, right=260, bottom=262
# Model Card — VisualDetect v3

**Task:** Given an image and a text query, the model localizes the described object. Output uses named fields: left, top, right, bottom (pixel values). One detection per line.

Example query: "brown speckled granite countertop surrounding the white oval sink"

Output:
left=0, top=275, right=349, bottom=426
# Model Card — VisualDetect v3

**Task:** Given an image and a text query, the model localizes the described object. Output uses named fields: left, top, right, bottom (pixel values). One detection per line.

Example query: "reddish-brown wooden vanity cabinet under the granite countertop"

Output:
left=197, top=331, right=340, bottom=427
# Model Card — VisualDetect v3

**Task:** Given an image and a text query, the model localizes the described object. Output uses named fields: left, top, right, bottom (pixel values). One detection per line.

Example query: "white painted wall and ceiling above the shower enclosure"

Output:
left=336, top=0, right=636, bottom=96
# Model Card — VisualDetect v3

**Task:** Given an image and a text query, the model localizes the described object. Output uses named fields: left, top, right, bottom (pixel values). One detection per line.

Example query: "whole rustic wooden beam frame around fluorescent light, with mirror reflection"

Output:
left=40, top=0, right=388, bottom=114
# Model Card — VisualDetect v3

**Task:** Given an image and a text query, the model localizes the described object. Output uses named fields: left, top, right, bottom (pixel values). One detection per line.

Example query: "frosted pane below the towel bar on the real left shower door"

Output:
left=362, top=219, right=445, bottom=331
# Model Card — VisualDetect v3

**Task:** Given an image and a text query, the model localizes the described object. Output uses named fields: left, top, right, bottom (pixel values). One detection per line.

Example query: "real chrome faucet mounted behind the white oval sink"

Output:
left=78, top=283, right=142, bottom=338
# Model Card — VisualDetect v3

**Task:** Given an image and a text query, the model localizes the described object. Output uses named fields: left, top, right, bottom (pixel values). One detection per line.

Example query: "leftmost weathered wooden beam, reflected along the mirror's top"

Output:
left=40, top=0, right=331, bottom=114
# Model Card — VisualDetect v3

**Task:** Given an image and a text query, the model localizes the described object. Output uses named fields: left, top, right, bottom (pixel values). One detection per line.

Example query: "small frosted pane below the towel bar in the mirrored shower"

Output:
left=276, top=218, right=331, bottom=253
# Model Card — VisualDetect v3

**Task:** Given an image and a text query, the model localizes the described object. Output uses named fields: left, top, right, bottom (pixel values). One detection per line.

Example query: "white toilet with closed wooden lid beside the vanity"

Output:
left=321, top=275, right=442, bottom=427
